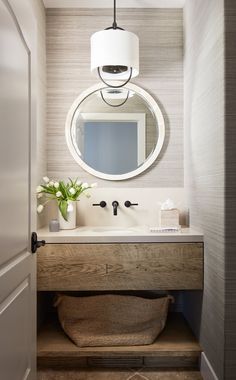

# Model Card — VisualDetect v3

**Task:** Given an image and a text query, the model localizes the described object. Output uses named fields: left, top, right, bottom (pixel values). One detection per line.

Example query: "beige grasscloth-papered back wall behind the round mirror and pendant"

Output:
left=47, top=9, right=183, bottom=187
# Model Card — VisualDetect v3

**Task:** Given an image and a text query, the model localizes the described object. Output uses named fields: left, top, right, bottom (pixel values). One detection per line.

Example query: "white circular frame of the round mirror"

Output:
left=65, top=83, right=165, bottom=181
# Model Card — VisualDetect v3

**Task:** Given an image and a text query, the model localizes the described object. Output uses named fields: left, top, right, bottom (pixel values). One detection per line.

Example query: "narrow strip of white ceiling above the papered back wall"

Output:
left=43, top=0, right=185, bottom=8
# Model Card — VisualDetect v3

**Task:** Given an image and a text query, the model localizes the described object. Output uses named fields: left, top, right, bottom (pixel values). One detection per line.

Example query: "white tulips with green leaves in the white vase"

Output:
left=37, top=177, right=97, bottom=221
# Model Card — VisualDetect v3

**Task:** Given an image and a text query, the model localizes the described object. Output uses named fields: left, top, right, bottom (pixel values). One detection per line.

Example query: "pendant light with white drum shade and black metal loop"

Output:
left=91, top=0, right=139, bottom=88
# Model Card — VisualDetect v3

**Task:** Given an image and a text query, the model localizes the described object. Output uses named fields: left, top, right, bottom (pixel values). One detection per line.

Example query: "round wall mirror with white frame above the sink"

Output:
left=65, top=83, right=165, bottom=181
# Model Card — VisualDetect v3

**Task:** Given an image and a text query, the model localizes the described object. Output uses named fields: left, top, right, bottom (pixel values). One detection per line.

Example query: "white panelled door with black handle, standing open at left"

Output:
left=0, top=0, right=36, bottom=380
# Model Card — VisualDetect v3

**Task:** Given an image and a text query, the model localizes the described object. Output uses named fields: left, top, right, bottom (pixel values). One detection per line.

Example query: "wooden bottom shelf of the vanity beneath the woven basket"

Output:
left=37, top=313, right=201, bottom=368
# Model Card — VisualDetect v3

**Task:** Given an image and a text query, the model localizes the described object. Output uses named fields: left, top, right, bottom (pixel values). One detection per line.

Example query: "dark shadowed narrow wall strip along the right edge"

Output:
left=225, top=0, right=236, bottom=380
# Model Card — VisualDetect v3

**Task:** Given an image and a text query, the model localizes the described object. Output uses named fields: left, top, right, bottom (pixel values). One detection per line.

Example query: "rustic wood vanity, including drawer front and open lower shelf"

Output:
left=37, top=230, right=203, bottom=367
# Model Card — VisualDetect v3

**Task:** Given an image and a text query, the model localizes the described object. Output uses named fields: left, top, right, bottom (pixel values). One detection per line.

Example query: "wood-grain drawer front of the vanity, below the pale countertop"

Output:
left=37, top=243, right=203, bottom=291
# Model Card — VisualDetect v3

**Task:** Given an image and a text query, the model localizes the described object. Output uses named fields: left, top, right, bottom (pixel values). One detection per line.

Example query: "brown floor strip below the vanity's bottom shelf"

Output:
left=37, top=368, right=202, bottom=380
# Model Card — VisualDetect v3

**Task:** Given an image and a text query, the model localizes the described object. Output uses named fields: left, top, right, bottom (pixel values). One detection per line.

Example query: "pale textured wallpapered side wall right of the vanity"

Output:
left=184, top=0, right=226, bottom=380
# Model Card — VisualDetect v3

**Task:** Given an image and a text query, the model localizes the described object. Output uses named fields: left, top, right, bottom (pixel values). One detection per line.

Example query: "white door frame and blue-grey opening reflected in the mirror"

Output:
left=74, top=112, right=146, bottom=174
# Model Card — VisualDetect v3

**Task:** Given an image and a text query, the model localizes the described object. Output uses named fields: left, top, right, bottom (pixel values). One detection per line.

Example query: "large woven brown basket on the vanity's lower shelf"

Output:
left=55, top=294, right=172, bottom=347
